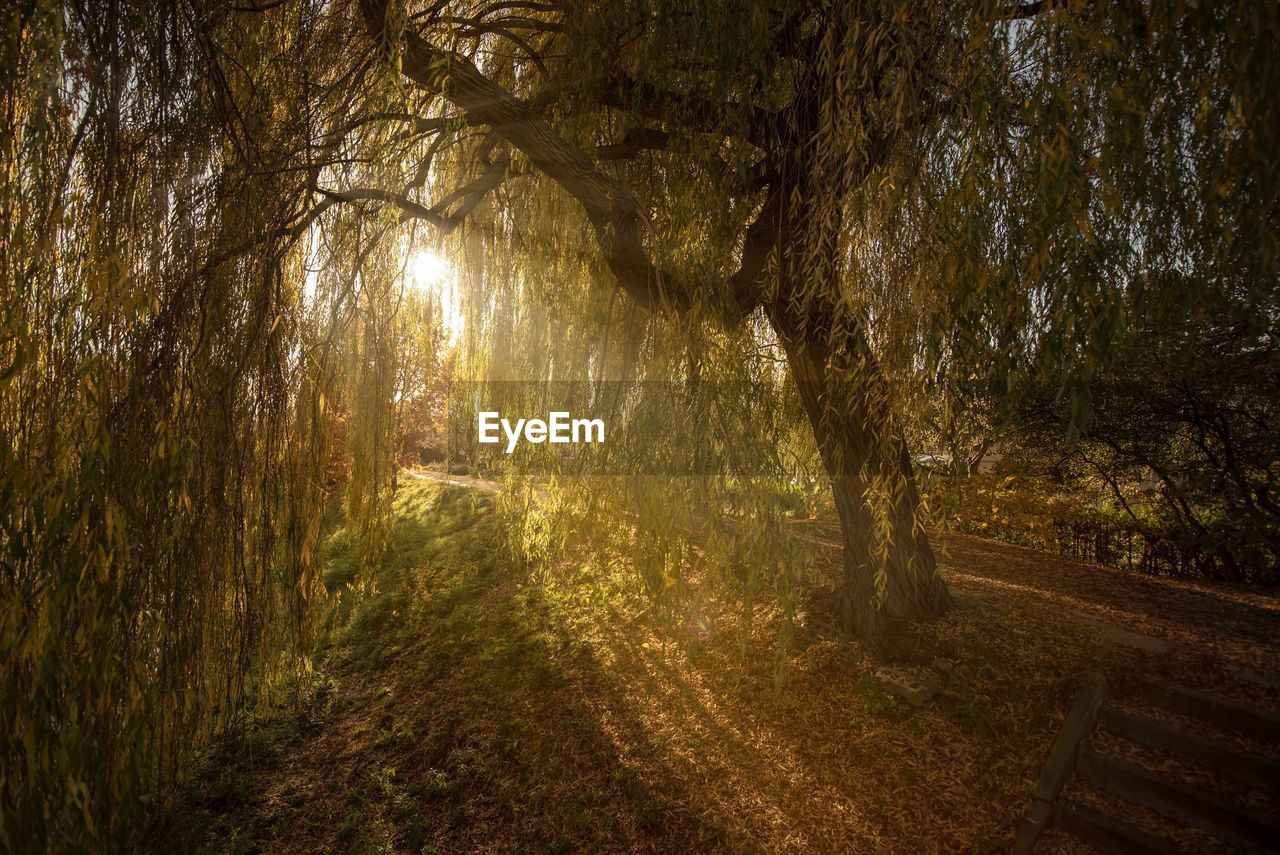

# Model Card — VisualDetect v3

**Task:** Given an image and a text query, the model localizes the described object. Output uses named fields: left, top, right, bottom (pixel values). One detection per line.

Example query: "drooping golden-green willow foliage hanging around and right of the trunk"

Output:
left=373, top=4, right=1277, bottom=622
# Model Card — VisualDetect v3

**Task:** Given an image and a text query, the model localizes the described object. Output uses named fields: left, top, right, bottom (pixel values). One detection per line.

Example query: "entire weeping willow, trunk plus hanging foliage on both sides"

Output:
left=0, top=0, right=1280, bottom=849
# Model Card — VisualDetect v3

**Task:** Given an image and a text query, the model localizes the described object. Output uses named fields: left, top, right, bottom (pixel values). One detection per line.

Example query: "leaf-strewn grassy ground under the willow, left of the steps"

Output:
left=148, top=481, right=1275, bottom=852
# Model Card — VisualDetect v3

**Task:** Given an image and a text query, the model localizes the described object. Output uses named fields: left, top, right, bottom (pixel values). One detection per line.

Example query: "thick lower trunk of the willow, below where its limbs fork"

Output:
left=767, top=300, right=951, bottom=643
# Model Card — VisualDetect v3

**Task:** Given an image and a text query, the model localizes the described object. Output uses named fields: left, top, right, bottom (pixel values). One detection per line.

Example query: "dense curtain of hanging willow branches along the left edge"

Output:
left=0, top=3, right=407, bottom=851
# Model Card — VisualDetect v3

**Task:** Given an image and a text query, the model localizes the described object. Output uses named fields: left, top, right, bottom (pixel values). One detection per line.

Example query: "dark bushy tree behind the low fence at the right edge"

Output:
left=1018, top=274, right=1280, bottom=582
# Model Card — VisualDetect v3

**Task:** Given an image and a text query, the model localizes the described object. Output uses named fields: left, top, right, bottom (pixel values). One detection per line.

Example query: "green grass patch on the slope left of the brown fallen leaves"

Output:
left=155, top=480, right=634, bottom=852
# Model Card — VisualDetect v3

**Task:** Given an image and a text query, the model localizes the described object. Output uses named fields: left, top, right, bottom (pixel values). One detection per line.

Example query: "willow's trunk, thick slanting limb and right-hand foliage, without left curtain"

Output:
left=332, top=0, right=1280, bottom=637
